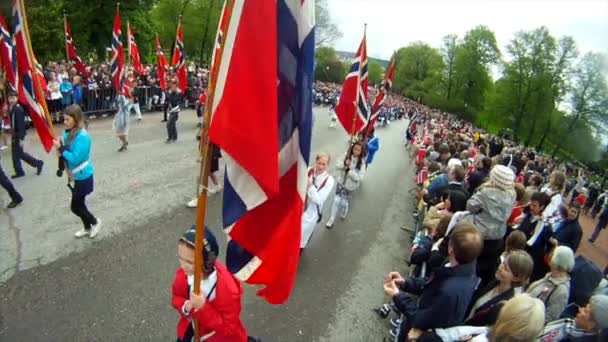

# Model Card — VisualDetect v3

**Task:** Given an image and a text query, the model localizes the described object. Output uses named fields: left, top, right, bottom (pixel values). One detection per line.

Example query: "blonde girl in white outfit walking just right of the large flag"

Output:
left=300, top=152, right=335, bottom=248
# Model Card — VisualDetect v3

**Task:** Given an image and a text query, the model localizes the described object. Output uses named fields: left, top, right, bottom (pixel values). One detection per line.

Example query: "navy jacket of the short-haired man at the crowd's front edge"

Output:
left=393, top=262, right=479, bottom=330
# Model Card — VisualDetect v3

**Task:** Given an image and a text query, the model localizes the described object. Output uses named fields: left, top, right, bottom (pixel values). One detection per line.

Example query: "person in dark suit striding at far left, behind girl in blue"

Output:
left=8, top=92, right=44, bottom=178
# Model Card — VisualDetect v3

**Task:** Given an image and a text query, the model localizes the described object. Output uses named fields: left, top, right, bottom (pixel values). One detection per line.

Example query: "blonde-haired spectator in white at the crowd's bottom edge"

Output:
left=417, top=293, right=545, bottom=342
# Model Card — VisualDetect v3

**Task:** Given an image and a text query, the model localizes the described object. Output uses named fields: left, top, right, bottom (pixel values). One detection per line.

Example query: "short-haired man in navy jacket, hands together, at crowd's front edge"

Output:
left=384, top=224, right=483, bottom=341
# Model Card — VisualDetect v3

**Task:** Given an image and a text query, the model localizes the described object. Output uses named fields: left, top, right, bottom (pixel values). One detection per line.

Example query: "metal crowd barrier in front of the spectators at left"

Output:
left=48, top=86, right=201, bottom=117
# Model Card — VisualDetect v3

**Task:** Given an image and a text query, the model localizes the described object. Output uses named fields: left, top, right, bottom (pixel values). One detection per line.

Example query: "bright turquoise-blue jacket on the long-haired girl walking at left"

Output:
left=61, top=128, right=95, bottom=180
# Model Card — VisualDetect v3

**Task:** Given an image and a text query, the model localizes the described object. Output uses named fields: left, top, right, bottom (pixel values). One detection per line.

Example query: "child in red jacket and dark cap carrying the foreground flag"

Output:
left=171, top=228, right=248, bottom=342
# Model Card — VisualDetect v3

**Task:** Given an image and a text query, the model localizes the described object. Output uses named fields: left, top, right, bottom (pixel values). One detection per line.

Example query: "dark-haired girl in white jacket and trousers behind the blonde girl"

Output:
left=325, top=141, right=365, bottom=229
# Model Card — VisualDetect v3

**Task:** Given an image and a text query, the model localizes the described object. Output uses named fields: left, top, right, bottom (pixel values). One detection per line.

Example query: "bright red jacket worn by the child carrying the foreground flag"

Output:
left=171, top=261, right=247, bottom=342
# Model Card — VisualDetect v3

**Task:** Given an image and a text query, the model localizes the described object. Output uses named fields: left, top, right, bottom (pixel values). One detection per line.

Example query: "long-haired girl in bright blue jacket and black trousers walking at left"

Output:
left=54, top=105, right=101, bottom=238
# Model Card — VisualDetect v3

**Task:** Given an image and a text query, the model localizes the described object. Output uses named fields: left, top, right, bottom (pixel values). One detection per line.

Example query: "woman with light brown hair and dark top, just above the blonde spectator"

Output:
left=464, top=250, right=534, bottom=326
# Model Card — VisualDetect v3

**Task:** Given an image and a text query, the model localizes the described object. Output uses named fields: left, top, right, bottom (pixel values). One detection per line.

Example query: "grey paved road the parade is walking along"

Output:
left=0, top=108, right=413, bottom=342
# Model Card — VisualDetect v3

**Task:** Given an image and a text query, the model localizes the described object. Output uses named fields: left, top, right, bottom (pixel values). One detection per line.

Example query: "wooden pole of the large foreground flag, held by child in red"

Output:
left=193, top=0, right=234, bottom=341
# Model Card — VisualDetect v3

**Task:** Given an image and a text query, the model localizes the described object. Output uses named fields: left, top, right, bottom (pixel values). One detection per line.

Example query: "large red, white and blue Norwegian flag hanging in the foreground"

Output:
left=209, top=0, right=315, bottom=304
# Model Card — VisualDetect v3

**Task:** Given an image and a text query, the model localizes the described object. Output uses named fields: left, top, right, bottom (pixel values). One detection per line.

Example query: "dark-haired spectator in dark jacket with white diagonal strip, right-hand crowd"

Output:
left=517, top=192, right=553, bottom=281
